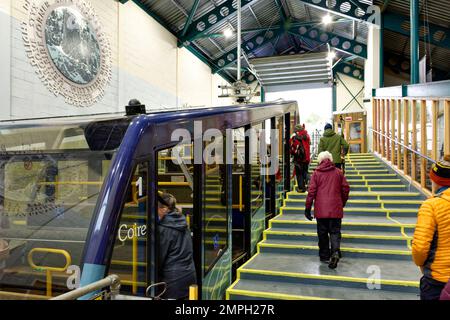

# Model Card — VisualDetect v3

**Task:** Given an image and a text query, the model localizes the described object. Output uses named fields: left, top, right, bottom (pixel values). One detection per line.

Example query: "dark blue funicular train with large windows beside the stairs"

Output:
left=0, top=102, right=298, bottom=299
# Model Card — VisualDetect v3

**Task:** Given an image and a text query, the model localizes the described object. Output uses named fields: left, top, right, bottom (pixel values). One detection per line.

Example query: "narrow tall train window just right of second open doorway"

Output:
left=250, top=123, right=265, bottom=215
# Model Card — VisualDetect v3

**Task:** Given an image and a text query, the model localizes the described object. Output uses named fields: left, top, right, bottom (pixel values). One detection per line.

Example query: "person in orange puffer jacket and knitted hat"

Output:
left=412, top=155, right=450, bottom=300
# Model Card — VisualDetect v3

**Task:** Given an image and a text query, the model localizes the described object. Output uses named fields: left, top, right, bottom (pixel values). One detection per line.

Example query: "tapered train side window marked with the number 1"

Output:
left=109, top=162, right=149, bottom=296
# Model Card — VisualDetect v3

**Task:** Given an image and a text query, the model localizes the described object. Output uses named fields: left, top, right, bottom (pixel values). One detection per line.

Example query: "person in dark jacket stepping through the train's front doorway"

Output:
left=158, top=193, right=197, bottom=299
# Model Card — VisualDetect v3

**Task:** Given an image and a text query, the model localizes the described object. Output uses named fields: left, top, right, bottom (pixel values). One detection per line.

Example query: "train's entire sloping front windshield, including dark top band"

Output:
left=0, top=118, right=129, bottom=299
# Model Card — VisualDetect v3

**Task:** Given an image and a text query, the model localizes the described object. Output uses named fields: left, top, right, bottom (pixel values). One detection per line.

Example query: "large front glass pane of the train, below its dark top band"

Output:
left=0, top=152, right=112, bottom=299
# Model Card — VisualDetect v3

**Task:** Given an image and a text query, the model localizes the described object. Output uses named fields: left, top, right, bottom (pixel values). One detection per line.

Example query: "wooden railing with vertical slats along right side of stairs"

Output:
left=372, top=82, right=450, bottom=194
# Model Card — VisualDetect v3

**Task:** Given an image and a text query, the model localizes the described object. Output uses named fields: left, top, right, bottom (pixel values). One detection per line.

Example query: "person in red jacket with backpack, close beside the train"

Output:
left=289, top=124, right=311, bottom=193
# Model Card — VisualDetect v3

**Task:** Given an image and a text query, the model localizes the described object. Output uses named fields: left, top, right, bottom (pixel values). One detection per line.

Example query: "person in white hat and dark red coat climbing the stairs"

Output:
left=305, top=151, right=350, bottom=269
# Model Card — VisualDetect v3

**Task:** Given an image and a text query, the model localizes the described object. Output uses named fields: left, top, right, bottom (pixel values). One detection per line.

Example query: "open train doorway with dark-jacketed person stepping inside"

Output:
left=151, top=142, right=195, bottom=299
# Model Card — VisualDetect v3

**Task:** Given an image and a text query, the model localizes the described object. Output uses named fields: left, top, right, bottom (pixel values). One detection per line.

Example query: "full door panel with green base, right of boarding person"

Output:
left=199, top=132, right=232, bottom=300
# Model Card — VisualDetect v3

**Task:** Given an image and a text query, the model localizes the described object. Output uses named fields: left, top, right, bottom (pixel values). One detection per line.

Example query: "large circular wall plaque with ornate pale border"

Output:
left=22, top=0, right=112, bottom=107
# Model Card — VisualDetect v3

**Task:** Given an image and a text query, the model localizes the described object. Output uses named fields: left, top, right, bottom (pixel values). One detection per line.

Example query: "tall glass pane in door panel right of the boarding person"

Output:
left=202, top=138, right=228, bottom=274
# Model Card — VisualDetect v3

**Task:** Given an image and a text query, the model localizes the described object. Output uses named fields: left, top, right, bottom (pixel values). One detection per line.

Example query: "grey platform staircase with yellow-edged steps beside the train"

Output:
left=227, top=154, right=425, bottom=300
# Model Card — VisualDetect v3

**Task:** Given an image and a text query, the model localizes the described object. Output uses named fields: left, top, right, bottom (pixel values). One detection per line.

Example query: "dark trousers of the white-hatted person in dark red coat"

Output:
left=317, top=219, right=342, bottom=260
